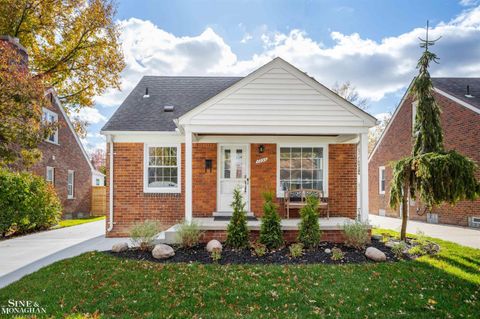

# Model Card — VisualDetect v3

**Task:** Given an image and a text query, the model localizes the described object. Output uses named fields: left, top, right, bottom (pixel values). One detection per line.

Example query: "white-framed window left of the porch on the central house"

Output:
left=144, top=145, right=180, bottom=193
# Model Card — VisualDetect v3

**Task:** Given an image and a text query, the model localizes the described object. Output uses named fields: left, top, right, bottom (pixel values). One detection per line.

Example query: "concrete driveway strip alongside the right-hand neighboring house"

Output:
left=369, top=215, right=480, bottom=249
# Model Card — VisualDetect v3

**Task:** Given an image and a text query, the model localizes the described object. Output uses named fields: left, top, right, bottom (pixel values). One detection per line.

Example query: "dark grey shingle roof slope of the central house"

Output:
left=102, top=76, right=242, bottom=131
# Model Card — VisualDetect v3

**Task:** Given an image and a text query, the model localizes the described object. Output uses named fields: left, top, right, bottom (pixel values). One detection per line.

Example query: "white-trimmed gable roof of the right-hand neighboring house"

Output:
left=368, top=78, right=480, bottom=161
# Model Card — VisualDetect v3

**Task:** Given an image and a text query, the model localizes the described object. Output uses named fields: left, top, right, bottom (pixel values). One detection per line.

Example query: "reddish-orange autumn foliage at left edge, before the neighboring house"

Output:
left=0, top=41, right=55, bottom=168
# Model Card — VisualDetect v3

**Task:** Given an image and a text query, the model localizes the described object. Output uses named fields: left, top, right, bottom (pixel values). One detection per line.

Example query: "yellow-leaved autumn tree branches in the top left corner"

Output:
left=0, top=0, right=124, bottom=131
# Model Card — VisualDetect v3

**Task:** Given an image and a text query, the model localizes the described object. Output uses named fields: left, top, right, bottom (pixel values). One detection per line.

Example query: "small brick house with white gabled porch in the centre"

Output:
left=102, top=58, right=376, bottom=240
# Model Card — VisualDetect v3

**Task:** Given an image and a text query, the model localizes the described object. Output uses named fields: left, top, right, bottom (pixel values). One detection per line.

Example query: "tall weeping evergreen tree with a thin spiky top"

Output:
left=390, top=24, right=480, bottom=240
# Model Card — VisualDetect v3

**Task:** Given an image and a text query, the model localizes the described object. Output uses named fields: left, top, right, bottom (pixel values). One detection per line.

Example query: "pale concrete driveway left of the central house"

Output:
left=0, top=220, right=126, bottom=288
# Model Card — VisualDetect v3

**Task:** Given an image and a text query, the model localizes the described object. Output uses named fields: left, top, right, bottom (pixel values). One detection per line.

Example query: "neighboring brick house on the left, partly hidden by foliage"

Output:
left=0, top=36, right=94, bottom=217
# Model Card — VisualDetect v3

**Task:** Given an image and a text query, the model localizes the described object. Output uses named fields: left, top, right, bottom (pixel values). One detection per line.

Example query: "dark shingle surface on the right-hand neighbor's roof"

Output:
left=432, top=78, right=480, bottom=109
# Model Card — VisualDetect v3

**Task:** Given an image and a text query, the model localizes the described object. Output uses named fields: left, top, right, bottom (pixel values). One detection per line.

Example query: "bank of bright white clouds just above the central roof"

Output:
left=97, top=7, right=480, bottom=106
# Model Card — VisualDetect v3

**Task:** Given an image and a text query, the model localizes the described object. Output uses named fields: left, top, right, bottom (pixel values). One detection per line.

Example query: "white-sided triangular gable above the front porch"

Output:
left=179, top=57, right=377, bottom=131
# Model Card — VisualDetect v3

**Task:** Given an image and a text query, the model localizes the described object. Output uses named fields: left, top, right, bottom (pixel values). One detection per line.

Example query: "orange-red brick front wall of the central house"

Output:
left=107, top=143, right=357, bottom=236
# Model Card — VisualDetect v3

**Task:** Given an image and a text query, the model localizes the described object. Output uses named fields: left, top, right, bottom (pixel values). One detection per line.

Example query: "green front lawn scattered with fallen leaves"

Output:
left=0, top=230, right=480, bottom=318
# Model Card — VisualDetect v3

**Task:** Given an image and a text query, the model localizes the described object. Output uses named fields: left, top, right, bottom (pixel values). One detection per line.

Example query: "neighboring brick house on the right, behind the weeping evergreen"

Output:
left=368, top=78, right=480, bottom=227
